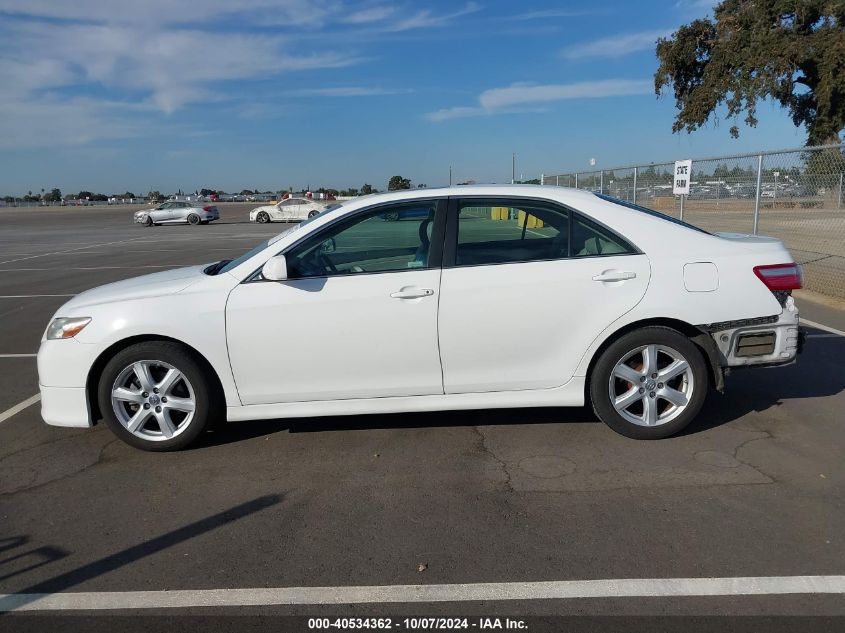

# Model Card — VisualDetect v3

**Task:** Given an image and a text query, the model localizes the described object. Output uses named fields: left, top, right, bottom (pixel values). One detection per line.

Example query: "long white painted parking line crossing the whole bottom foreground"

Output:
left=0, top=576, right=845, bottom=612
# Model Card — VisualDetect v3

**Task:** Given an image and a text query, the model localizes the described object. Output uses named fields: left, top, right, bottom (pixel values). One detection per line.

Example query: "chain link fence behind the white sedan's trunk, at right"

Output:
left=540, top=145, right=845, bottom=298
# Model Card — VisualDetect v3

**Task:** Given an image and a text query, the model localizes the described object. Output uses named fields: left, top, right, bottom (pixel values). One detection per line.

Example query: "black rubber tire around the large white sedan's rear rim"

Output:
left=589, top=326, right=710, bottom=440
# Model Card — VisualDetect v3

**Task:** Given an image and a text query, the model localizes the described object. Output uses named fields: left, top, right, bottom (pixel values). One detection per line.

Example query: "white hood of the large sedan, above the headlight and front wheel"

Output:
left=62, top=264, right=207, bottom=316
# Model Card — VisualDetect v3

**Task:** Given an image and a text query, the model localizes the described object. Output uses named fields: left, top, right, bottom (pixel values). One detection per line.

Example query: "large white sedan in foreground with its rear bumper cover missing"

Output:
left=38, top=186, right=801, bottom=450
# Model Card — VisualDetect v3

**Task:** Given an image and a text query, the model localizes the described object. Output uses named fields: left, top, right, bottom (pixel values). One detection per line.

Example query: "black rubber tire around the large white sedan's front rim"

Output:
left=97, top=341, right=225, bottom=452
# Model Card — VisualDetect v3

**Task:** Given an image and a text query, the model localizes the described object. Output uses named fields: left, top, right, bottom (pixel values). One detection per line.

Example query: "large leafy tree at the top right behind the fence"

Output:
left=654, top=0, right=845, bottom=145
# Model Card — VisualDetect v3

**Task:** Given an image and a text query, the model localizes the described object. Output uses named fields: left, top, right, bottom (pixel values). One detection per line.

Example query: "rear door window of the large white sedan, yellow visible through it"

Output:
left=455, top=200, right=569, bottom=266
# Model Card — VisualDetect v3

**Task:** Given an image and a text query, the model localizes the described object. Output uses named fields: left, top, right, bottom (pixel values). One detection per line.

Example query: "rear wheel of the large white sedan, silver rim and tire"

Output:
left=590, top=326, right=709, bottom=440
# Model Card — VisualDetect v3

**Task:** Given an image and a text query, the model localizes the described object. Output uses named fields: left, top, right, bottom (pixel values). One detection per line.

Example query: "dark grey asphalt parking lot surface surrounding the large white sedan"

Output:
left=0, top=205, right=845, bottom=615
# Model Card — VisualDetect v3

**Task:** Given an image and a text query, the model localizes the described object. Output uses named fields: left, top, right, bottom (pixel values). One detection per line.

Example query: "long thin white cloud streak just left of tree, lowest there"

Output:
left=426, top=79, right=654, bottom=123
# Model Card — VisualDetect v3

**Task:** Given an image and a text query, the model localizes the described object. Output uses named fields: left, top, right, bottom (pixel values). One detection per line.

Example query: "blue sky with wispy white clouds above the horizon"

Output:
left=0, top=0, right=805, bottom=194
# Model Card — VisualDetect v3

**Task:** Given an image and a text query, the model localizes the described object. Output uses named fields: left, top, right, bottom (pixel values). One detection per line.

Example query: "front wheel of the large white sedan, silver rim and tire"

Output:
left=98, top=341, right=223, bottom=451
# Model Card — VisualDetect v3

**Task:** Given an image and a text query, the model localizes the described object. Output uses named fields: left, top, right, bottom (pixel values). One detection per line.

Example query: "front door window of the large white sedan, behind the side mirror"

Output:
left=285, top=200, right=437, bottom=279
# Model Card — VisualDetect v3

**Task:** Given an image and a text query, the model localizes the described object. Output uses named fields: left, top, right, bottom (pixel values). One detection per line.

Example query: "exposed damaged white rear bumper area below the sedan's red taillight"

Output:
left=711, top=297, right=802, bottom=367
